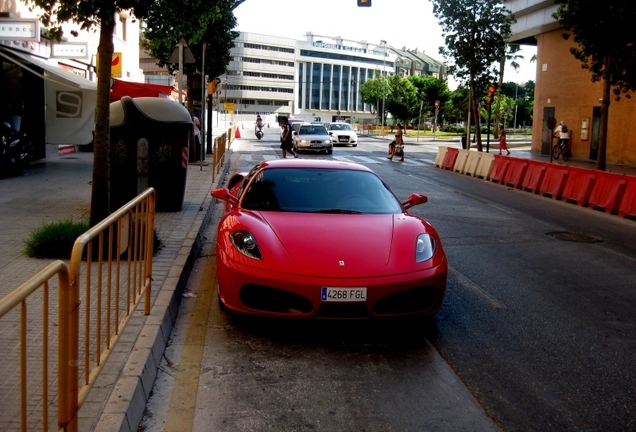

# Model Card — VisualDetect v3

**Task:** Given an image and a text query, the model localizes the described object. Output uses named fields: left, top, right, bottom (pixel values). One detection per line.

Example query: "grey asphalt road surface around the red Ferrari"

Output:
left=143, top=130, right=636, bottom=431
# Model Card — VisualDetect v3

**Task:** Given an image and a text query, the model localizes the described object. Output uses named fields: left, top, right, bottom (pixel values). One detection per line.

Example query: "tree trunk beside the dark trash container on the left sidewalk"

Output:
left=90, top=15, right=115, bottom=227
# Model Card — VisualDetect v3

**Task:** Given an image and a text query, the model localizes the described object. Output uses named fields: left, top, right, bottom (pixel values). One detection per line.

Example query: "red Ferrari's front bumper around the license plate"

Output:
left=217, top=251, right=448, bottom=319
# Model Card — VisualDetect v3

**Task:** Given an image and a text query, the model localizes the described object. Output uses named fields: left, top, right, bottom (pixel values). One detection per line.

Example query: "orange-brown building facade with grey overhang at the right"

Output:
left=505, top=0, right=636, bottom=165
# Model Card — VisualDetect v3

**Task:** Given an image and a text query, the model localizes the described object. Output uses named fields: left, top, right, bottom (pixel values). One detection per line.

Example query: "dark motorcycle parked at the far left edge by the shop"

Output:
left=0, top=116, right=31, bottom=178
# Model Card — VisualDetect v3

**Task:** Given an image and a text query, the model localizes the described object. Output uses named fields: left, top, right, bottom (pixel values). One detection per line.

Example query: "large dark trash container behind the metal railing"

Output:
left=110, top=96, right=192, bottom=212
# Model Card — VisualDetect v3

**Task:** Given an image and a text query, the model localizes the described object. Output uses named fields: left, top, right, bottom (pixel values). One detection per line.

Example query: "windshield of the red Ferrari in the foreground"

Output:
left=241, top=168, right=402, bottom=214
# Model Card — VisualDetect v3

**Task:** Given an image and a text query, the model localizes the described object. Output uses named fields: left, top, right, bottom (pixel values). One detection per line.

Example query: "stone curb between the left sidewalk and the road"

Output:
left=93, top=150, right=231, bottom=432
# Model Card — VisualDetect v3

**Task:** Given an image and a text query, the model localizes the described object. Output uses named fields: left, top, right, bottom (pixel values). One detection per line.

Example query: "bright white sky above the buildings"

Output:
left=234, top=0, right=536, bottom=89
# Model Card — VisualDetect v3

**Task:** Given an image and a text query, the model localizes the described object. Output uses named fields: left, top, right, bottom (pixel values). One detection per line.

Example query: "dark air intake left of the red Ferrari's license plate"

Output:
left=239, top=285, right=313, bottom=314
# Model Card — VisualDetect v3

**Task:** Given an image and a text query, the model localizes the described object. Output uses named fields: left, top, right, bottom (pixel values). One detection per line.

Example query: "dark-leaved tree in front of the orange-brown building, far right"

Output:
left=554, top=0, right=636, bottom=170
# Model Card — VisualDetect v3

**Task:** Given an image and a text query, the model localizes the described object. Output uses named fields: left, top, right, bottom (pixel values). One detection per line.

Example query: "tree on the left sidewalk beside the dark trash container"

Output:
left=27, top=0, right=153, bottom=226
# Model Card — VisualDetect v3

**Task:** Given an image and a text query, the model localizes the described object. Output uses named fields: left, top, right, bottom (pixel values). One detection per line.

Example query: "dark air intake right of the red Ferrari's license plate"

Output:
left=373, top=286, right=439, bottom=315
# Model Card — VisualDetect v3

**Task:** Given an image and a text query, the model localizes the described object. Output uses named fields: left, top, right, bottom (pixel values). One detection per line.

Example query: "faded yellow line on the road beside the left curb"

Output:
left=164, top=253, right=216, bottom=432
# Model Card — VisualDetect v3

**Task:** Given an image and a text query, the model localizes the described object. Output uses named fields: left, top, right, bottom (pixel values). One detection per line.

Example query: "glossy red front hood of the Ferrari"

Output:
left=262, top=212, right=395, bottom=272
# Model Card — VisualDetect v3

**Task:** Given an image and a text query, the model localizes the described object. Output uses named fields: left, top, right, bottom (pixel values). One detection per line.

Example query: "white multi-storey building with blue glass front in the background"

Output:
left=216, top=32, right=443, bottom=121
